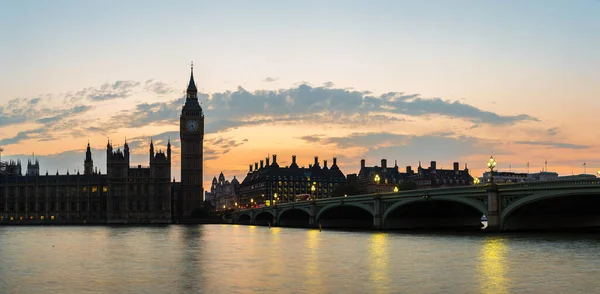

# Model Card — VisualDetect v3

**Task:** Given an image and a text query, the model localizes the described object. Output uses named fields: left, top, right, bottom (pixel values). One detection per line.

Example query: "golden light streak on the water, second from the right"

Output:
left=369, top=233, right=390, bottom=293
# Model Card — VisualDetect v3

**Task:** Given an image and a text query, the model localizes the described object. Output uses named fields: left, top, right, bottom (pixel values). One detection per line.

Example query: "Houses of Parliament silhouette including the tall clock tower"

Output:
left=0, top=67, right=204, bottom=224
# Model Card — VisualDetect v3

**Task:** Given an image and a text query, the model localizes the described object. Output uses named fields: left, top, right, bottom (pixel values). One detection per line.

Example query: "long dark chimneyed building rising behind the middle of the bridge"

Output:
left=348, top=159, right=473, bottom=193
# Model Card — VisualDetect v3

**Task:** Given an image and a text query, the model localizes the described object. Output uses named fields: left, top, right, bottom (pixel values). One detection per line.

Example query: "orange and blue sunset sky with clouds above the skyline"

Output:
left=0, top=0, right=600, bottom=188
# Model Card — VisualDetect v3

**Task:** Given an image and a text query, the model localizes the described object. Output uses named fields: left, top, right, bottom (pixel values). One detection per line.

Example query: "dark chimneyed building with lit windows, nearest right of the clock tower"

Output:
left=238, top=155, right=346, bottom=207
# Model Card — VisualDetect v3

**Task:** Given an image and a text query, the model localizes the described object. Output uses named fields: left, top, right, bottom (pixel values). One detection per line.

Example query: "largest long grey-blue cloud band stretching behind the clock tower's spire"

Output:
left=111, top=82, right=538, bottom=133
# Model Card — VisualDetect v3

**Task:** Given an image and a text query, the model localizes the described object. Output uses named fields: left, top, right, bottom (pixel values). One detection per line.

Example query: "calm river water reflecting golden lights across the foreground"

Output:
left=0, top=225, right=600, bottom=294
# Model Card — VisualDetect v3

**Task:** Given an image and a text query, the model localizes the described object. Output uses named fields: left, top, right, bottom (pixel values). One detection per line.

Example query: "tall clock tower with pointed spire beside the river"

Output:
left=175, top=64, right=204, bottom=219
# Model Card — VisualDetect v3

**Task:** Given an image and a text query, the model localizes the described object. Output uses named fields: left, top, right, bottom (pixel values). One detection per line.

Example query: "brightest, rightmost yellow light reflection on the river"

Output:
left=478, top=237, right=510, bottom=293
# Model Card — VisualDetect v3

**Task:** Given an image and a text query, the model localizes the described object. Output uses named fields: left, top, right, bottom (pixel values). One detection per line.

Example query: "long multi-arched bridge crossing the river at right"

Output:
left=232, top=178, right=600, bottom=231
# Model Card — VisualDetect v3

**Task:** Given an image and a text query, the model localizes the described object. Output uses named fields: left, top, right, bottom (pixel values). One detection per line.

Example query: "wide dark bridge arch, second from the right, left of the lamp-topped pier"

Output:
left=381, top=196, right=488, bottom=229
